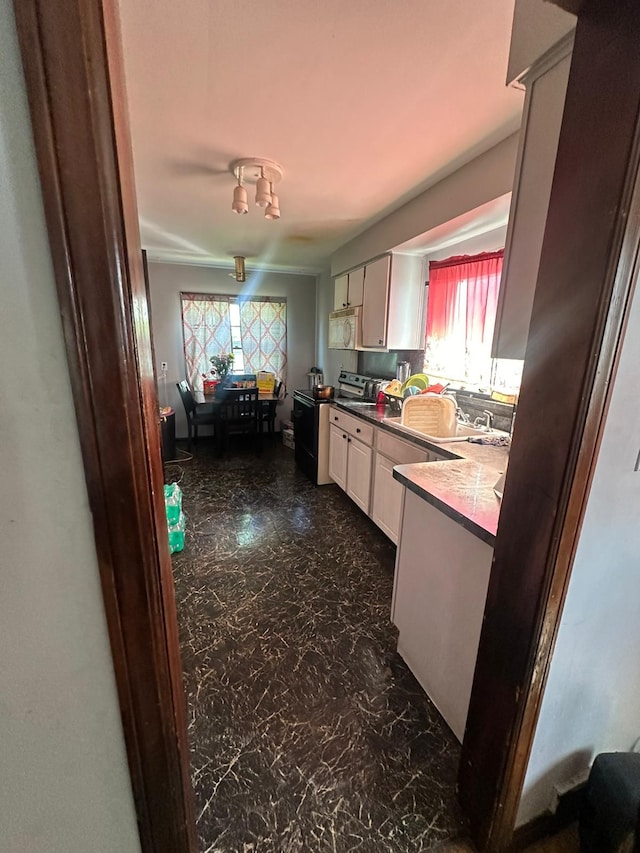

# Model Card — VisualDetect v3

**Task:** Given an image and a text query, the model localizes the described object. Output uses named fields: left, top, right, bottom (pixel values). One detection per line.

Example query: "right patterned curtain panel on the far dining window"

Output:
left=238, top=298, right=287, bottom=382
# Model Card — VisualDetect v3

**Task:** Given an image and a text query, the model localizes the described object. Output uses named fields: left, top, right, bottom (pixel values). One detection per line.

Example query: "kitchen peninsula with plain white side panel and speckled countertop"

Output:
left=334, top=400, right=509, bottom=741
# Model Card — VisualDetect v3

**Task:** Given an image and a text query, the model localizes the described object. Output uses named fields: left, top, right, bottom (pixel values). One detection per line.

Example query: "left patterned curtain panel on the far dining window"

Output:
left=180, top=293, right=231, bottom=391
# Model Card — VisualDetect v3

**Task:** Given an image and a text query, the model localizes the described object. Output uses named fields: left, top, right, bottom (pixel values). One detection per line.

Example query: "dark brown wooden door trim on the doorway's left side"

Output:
left=15, top=0, right=196, bottom=853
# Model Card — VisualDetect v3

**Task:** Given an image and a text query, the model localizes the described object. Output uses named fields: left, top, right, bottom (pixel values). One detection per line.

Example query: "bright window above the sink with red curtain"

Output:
left=425, top=249, right=522, bottom=390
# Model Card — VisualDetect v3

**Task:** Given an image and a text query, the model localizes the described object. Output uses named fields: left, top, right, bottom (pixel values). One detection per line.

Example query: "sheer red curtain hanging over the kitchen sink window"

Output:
left=427, top=249, right=504, bottom=344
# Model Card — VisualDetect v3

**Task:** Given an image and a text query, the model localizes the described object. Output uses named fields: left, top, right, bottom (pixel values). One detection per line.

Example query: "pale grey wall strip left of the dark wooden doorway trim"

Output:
left=0, top=0, right=140, bottom=853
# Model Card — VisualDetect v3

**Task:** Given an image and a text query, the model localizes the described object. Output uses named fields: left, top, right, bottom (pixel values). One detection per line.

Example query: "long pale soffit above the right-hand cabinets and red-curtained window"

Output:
left=331, top=133, right=518, bottom=276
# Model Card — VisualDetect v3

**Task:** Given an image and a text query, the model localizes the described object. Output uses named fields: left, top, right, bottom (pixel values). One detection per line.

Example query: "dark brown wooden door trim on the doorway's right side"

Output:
left=459, top=0, right=640, bottom=851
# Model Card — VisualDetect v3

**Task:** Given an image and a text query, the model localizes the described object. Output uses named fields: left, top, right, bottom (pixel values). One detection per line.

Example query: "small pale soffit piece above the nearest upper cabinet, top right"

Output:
left=507, top=0, right=576, bottom=83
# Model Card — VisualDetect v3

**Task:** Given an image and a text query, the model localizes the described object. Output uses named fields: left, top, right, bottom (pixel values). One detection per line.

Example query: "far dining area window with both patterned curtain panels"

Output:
left=180, top=293, right=287, bottom=390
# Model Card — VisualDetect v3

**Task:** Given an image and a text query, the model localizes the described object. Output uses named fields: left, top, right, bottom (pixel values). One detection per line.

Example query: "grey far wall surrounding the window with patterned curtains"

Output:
left=149, top=262, right=316, bottom=436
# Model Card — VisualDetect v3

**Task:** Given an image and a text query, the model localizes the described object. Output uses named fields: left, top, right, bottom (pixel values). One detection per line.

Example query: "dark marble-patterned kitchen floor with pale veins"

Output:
left=167, top=441, right=464, bottom=853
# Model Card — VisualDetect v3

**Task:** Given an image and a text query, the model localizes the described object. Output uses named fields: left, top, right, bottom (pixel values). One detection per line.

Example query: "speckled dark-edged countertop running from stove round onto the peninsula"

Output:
left=335, top=400, right=509, bottom=545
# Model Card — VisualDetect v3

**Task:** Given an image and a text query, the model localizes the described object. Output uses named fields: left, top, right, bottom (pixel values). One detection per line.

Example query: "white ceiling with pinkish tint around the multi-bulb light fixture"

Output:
left=120, top=0, right=522, bottom=270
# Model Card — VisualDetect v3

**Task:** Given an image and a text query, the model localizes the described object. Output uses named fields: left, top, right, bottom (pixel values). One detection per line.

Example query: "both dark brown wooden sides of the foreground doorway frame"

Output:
left=14, top=0, right=640, bottom=853
